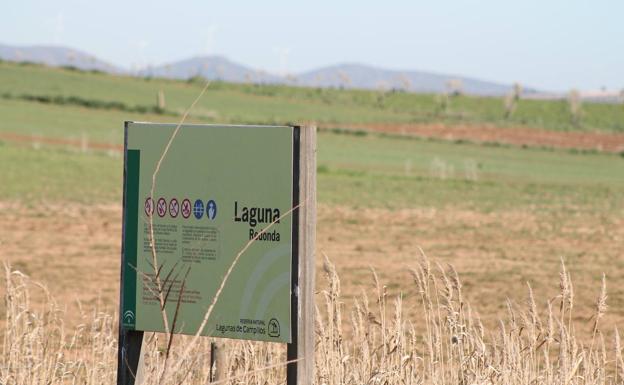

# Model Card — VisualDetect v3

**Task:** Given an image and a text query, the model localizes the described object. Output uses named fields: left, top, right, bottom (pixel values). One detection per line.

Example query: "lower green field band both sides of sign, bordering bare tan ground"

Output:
left=0, top=133, right=624, bottom=212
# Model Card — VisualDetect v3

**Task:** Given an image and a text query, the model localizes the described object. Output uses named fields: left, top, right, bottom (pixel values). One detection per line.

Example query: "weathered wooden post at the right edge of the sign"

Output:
left=286, top=126, right=316, bottom=385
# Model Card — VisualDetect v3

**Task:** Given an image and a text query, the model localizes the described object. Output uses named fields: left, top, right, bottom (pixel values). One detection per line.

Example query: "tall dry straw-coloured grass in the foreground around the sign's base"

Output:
left=0, top=250, right=624, bottom=385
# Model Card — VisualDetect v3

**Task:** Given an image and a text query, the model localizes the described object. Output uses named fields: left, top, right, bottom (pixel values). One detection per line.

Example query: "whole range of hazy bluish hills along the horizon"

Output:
left=0, top=45, right=537, bottom=96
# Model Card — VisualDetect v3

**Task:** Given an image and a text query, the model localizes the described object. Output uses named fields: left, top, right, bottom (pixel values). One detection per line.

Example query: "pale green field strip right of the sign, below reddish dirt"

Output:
left=319, top=134, right=624, bottom=212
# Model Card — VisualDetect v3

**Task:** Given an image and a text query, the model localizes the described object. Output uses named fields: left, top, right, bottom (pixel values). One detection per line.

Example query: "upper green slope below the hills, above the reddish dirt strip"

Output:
left=0, top=63, right=624, bottom=132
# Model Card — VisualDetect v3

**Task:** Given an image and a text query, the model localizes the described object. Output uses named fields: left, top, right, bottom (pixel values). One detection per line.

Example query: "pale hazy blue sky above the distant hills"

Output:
left=0, top=0, right=624, bottom=91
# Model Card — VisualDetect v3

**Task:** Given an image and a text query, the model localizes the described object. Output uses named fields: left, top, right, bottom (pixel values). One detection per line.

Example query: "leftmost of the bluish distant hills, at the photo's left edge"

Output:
left=0, top=44, right=124, bottom=73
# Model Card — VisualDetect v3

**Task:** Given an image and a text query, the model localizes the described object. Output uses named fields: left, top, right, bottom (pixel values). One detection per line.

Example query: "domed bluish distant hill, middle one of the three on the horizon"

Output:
left=138, top=56, right=284, bottom=83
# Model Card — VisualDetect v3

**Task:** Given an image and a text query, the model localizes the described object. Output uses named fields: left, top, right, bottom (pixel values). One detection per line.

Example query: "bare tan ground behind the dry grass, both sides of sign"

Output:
left=0, top=202, right=624, bottom=340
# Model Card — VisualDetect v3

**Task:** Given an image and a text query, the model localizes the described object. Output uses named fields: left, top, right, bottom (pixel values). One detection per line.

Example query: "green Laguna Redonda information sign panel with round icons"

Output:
left=122, top=122, right=299, bottom=342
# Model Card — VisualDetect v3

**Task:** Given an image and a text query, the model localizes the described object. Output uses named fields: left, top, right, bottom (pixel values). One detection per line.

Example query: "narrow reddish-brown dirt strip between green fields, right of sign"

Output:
left=326, top=123, right=624, bottom=152
